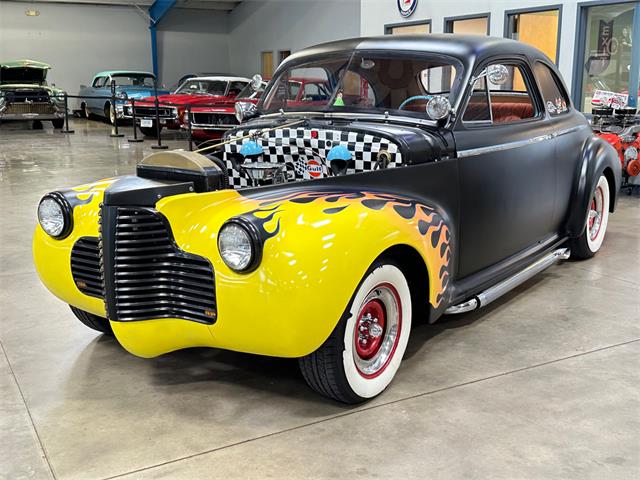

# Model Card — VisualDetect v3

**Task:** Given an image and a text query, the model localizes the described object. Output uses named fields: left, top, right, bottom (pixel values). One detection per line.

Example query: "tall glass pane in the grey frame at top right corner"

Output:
left=580, top=2, right=640, bottom=112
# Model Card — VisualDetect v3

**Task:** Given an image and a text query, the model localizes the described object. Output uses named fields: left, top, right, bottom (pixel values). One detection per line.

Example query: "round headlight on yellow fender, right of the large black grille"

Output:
left=218, top=218, right=261, bottom=272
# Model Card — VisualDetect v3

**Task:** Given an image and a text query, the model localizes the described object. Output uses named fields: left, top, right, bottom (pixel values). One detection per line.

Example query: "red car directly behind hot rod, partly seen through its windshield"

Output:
left=185, top=77, right=331, bottom=141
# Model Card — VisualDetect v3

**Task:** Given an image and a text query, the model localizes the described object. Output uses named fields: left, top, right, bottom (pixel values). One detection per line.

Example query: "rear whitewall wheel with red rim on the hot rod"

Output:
left=570, top=175, right=610, bottom=259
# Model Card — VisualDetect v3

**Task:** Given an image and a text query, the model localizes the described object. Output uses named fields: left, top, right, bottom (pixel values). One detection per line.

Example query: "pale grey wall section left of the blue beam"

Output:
left=0, top=1, right=151, bottom=93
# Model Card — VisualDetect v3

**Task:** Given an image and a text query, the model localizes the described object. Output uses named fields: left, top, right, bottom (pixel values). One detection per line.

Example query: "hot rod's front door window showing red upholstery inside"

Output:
left=462, top=64, right=537, bottom=124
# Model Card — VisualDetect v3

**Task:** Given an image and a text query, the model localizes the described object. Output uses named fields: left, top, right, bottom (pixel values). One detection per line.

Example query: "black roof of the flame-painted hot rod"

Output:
left=284, top=33, right=552, bottom=71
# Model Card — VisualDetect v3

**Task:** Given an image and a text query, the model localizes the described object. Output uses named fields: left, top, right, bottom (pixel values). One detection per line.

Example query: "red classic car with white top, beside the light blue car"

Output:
left=124, top=76, right=249, bottom=137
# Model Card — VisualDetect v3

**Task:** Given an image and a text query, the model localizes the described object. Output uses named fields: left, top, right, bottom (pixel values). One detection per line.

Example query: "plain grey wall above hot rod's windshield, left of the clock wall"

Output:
left=229, top=0, right=360, bottom=75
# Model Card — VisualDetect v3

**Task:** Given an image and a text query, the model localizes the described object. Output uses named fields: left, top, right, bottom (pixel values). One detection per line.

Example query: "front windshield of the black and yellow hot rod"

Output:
left=261, top=52, right=462, bottom=117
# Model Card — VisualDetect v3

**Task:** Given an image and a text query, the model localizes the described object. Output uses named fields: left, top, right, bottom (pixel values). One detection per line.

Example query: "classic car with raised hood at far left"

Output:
left=0, top=60, right=64, bottom=128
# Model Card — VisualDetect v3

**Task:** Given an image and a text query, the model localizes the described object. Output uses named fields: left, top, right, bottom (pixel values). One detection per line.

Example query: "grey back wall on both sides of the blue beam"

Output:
left=0, top=0, right=229, bottom=93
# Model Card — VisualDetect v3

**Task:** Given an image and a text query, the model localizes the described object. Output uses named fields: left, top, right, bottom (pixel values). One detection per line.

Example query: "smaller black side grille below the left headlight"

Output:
left=71, top=237, right=103, bottom=298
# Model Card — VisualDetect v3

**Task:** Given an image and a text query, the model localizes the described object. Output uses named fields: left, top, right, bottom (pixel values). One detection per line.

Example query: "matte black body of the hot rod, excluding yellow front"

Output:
left=226, top=34, right=621, bottom=321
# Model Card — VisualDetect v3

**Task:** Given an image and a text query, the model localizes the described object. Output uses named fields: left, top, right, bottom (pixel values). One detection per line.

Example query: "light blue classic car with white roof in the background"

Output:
left=78, top=70, right=169, bottom=124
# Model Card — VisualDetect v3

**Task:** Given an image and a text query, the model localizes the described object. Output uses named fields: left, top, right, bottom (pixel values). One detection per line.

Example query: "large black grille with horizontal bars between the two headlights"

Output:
left=112, top=207, right=216, bottom=323
